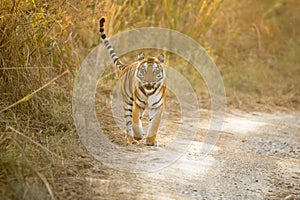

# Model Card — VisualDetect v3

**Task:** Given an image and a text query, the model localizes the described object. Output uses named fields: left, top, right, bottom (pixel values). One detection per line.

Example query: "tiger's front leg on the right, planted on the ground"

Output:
left=145, top=104, right=164, bottom=146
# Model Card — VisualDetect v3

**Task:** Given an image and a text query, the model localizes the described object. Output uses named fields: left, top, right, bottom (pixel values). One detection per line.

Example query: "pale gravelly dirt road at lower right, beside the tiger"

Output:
left=86, top=101, right=300, bottom=199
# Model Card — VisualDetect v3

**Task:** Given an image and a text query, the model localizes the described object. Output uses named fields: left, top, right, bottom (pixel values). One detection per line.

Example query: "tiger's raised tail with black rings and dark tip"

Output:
left=99, top=18, right=126, bottom=70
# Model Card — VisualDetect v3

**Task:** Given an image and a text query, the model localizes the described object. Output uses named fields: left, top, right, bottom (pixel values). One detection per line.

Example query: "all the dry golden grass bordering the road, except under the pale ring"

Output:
left=0, top=0, right=300, bottom=199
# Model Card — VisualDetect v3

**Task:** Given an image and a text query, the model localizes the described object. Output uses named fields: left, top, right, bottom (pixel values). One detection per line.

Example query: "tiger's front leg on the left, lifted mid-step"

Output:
left=132, top=102, right=144, bottom=140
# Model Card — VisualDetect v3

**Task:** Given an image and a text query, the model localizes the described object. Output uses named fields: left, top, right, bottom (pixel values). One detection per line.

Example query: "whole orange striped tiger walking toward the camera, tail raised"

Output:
left=99, top=18, right=167, bottom=146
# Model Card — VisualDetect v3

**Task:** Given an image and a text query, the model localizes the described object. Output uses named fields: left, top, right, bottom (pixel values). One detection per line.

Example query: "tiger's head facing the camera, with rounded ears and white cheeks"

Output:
left=136, top=53, right=165, bottom=93
